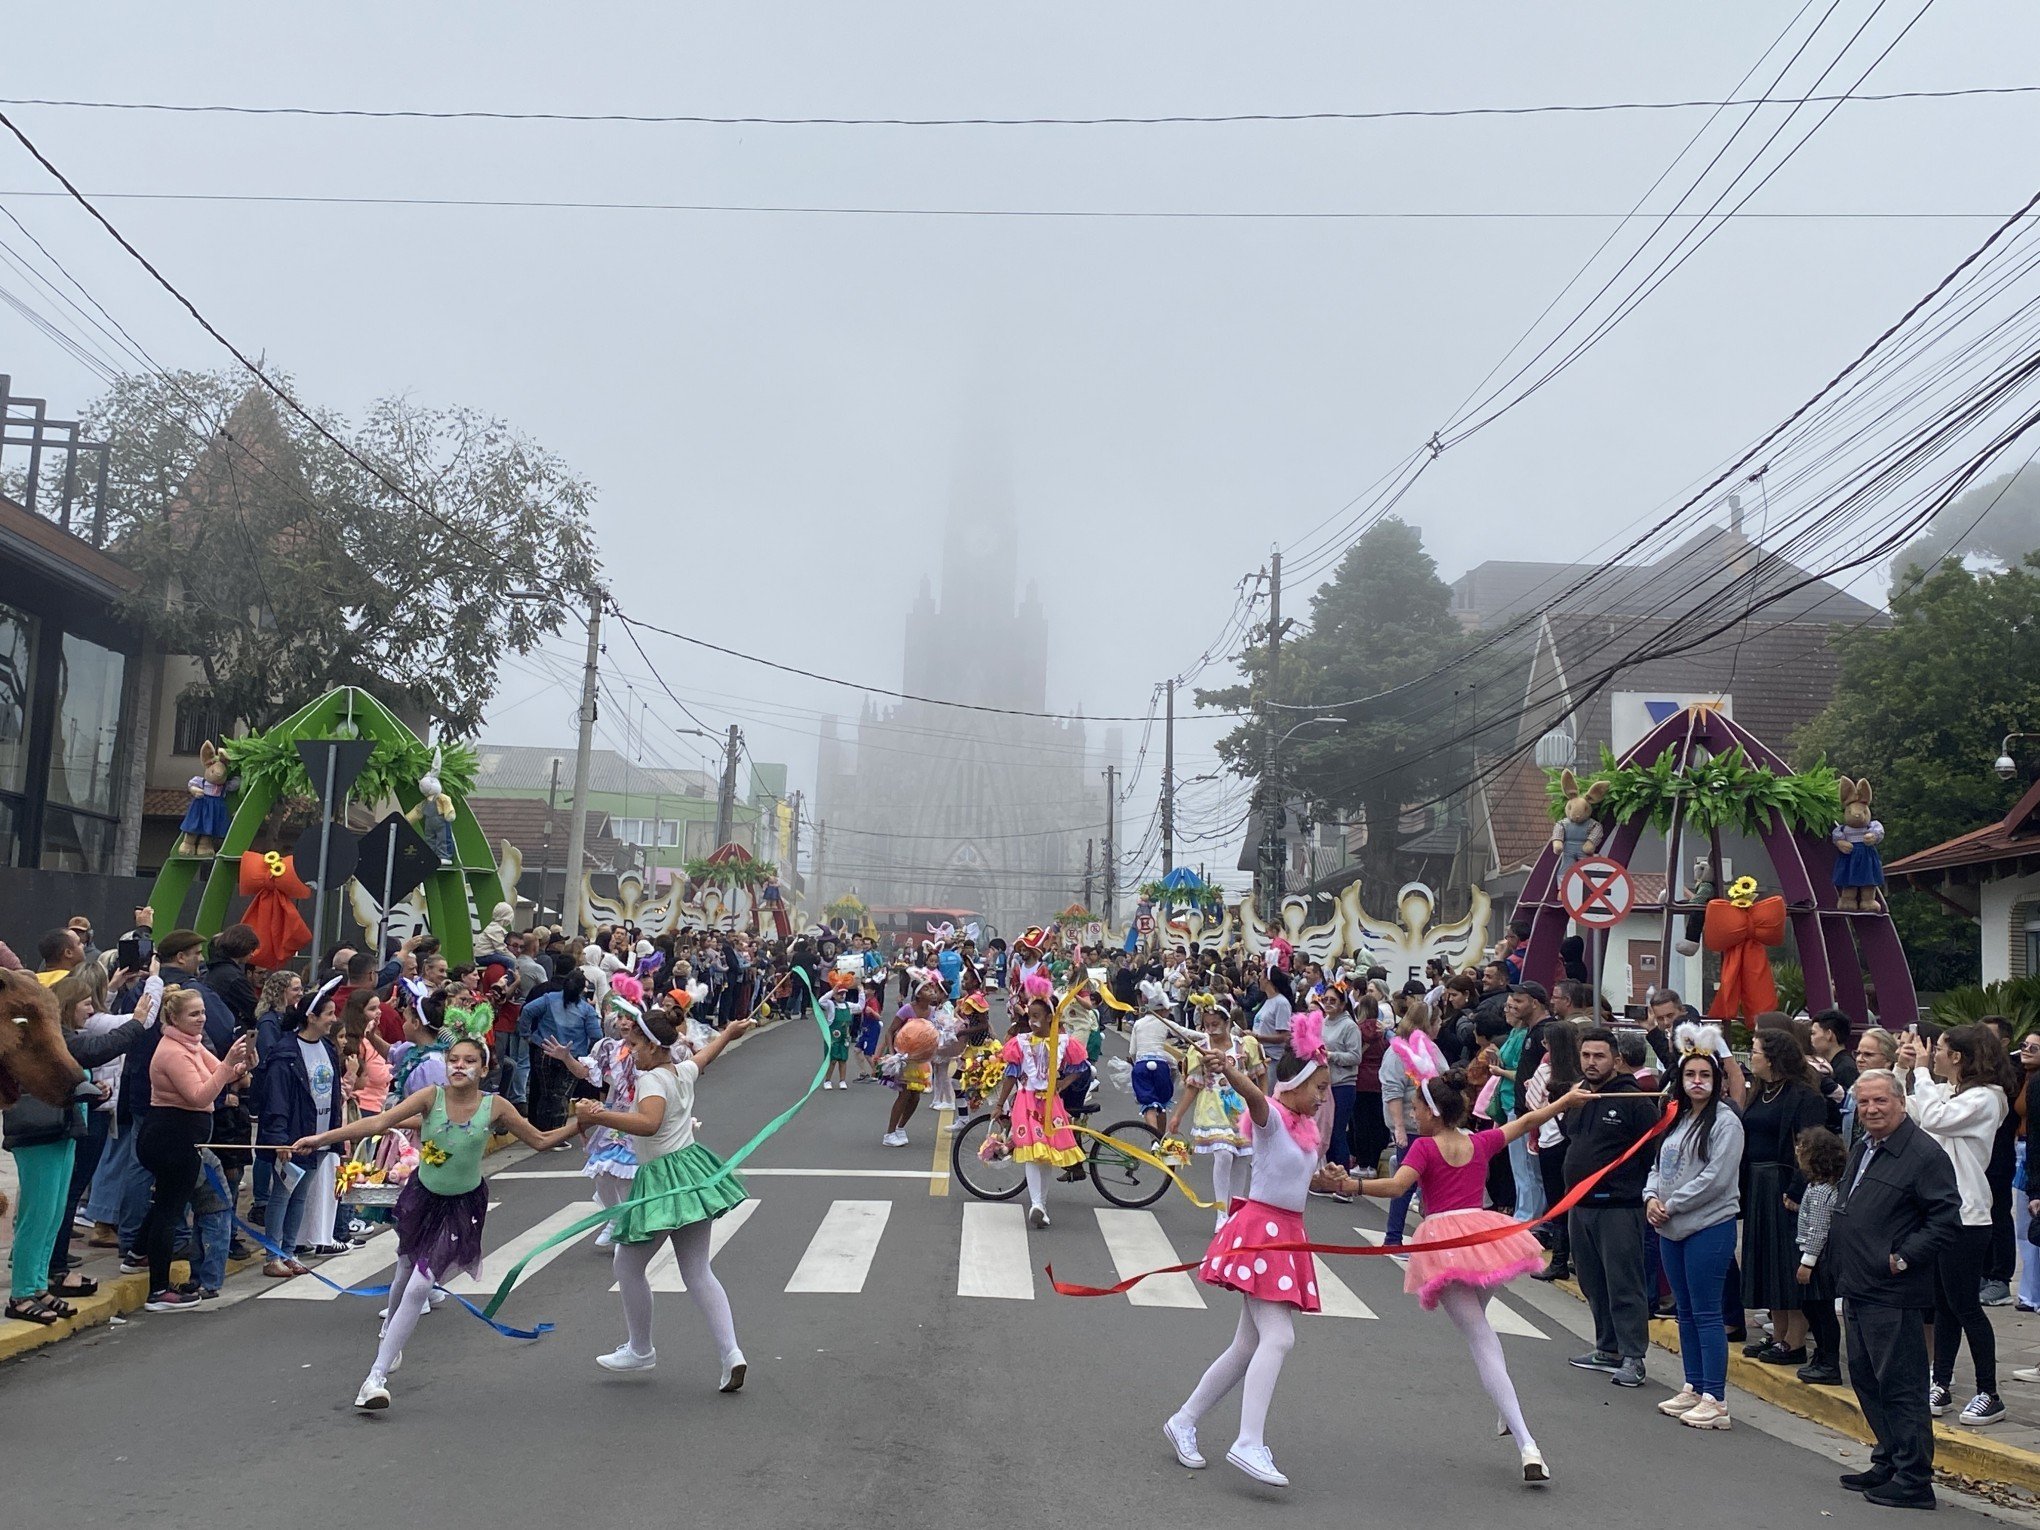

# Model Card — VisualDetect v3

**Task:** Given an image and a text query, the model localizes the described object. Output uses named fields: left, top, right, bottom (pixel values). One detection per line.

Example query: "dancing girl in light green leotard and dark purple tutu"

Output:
left=290, top=1036, right=581, bottom=1410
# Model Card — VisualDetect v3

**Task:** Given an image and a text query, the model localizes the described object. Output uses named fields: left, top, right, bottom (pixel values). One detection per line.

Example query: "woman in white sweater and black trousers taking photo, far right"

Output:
left=1899, top=1026, right=2007, bottom=1426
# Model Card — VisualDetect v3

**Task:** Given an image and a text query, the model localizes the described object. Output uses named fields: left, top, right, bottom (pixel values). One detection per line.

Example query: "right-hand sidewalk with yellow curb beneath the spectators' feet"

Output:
left=1557, top=1279, right=2040, bottom=1495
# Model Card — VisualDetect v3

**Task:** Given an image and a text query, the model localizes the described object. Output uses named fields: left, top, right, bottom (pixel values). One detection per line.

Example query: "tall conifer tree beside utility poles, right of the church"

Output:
left=1195, top=516, right=1467, bottom=887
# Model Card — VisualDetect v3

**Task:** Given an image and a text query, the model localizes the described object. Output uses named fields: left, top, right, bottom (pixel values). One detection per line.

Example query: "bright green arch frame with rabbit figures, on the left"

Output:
left=149, top=685, right=504, bottom=963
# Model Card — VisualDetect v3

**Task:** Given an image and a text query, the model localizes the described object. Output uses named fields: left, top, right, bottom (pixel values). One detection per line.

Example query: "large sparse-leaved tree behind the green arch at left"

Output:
left=88, top=371, right=598, bottom=736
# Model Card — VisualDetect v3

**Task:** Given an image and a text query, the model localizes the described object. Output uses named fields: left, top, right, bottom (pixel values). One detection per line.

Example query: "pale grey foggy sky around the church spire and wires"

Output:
left=0, top=0, right=2040, bottom=893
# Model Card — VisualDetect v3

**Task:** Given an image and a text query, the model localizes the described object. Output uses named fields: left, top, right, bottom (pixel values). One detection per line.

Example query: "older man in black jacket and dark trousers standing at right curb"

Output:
left=1824, top=1069, right=1962, bottom=1510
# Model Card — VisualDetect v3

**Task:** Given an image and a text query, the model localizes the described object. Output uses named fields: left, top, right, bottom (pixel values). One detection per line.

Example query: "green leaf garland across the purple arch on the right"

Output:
left=1544, top=745, right=1842, bottom=834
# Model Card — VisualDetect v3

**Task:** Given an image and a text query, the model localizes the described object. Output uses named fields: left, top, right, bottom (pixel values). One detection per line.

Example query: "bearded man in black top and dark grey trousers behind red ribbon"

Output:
left=1565, top=1026, right=1664, bottom=1397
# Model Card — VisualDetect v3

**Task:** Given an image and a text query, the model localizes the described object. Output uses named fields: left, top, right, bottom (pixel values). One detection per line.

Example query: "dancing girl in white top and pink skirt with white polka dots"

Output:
left=1163, top=1014, right=1332, bottom=1487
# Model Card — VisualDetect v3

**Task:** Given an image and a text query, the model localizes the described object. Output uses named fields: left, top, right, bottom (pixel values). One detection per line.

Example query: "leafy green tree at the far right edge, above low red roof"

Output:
left=1793, top=555, right=2040, bottom=991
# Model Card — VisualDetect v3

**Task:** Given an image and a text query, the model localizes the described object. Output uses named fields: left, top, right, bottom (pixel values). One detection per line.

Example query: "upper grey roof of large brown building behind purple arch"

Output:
left=1452, top=526, right=1883, bottom=628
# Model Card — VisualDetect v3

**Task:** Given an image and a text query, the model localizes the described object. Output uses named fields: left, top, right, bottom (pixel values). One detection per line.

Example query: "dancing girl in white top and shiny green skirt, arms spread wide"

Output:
left=573, top=1000, right=757, bottom=1391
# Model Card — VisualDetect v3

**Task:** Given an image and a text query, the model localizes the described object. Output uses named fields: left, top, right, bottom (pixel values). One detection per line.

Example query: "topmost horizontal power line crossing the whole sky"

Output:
left=0, top=86, right=2040, bottom=129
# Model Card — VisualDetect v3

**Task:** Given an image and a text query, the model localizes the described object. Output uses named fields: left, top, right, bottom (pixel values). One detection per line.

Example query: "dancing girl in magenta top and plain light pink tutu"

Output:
left=1318, top=1036, right=1587, bottom=1483
